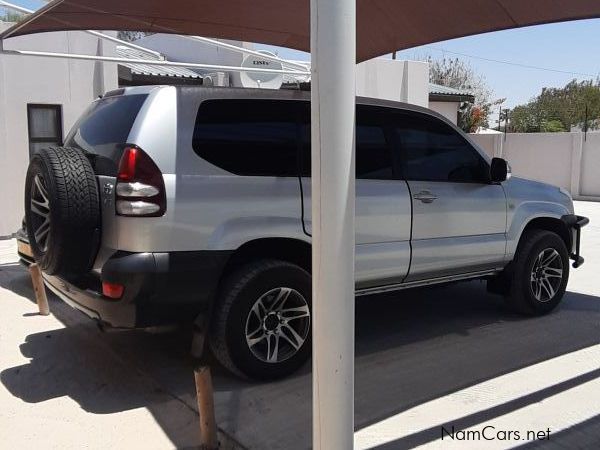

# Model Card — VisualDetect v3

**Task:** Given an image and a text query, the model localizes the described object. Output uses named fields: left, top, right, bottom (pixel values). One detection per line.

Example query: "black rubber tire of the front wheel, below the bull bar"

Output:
left=506, top=230, right=569, bottom=316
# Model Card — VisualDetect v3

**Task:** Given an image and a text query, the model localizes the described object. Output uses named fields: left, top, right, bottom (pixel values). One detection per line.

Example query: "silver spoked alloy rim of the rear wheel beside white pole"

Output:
left=245, top=287, right=310, bottom=363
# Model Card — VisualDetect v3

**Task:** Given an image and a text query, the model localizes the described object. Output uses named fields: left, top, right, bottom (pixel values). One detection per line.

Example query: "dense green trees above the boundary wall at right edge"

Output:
left=510, top=77, right=600, bottom=133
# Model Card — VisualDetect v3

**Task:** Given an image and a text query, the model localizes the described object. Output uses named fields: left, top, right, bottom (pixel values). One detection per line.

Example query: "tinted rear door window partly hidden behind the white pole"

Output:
left=302, top=105, right=393, bottom=180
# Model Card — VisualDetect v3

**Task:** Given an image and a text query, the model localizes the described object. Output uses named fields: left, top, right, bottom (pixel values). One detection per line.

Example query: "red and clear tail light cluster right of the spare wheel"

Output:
left=115, top=146, right=167, bottom=217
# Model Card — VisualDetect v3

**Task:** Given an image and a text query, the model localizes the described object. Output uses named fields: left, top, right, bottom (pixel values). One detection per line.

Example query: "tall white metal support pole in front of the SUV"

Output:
left=310, top=0, right=356, bottom=450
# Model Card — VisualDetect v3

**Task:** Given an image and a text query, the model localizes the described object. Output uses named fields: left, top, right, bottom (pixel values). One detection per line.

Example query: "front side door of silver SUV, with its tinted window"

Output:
left=393, top=111, right=506, bottom=281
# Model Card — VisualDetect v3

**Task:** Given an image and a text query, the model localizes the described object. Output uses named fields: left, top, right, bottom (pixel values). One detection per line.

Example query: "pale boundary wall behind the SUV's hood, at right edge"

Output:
left=471, top=132, right=600, bottom=200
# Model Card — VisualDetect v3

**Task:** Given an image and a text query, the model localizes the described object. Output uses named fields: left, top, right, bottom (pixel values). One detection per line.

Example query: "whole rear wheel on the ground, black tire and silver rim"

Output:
left=210, top=260, right=311, bottom=379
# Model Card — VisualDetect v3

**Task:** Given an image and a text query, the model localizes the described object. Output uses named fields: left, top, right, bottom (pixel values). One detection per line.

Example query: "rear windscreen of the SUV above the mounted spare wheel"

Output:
left=65, top=94, right=148, bottom=175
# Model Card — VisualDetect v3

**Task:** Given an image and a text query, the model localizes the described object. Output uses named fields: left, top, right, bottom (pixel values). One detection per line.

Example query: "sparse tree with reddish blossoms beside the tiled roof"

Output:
left=427, top=56, right=504, bottom=132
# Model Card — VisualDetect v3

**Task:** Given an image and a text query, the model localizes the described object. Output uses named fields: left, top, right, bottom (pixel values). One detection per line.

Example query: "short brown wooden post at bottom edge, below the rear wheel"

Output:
left=194, top=366, right=219, bottom=450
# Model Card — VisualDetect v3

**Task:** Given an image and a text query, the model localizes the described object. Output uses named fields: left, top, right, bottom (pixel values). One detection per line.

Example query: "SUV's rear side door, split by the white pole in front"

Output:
left=302, top=103, right=411, bottom=289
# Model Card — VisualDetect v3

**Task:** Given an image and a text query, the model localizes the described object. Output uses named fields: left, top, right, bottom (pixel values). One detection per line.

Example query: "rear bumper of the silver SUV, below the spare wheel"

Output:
left=44, top=251, right=231, bottom=328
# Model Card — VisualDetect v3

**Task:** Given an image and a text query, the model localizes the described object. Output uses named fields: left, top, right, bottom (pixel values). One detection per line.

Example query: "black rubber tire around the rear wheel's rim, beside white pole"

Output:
left=209, top=260, right=312, bottom=380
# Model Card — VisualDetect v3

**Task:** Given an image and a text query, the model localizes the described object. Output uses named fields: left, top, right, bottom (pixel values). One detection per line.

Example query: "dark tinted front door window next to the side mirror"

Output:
left=392, top=112, right=489, bottom=183
